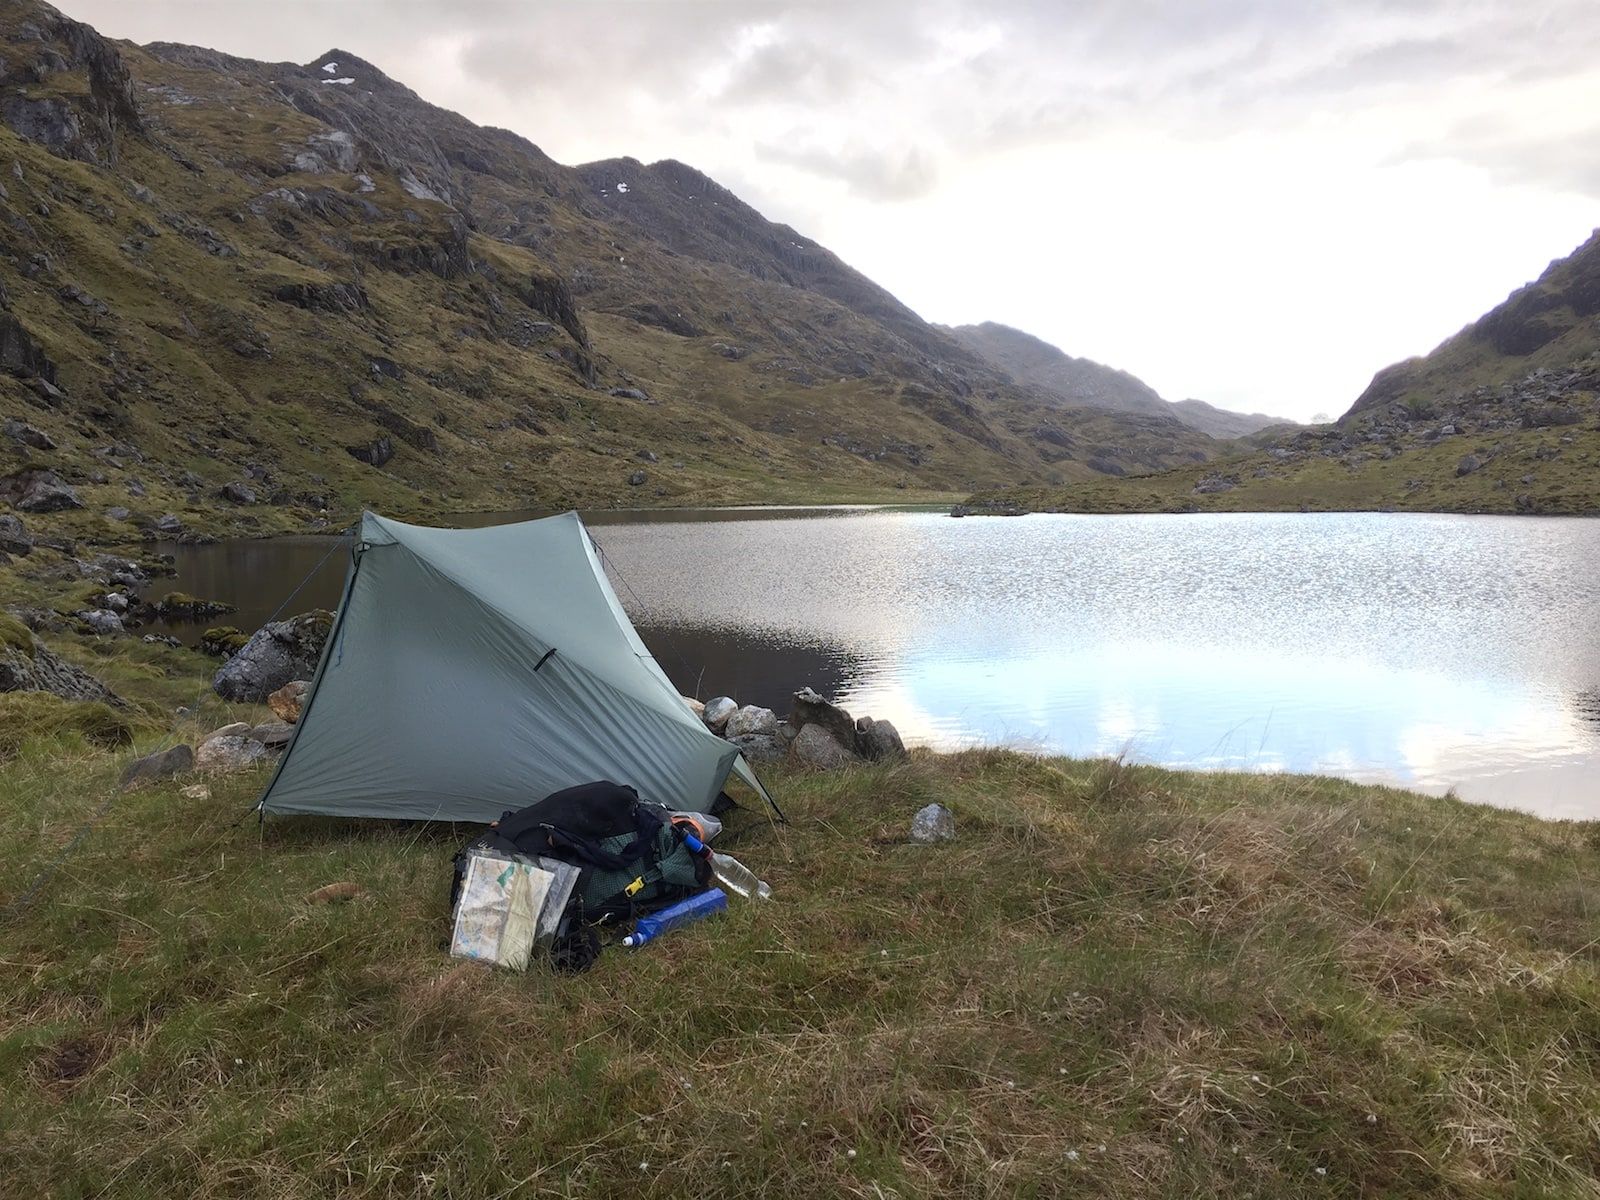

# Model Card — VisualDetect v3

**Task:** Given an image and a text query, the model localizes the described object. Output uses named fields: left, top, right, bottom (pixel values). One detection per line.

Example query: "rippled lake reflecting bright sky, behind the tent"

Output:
left=162, top=509, right=1600, bottom=818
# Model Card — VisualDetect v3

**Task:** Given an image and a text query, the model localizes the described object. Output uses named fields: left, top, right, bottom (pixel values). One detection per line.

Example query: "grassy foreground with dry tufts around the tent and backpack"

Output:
left=0, top=723, right=1600, bottom=1197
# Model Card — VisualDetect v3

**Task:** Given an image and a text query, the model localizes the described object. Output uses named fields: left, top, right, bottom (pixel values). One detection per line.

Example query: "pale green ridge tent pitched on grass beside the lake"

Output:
left=261, top=512, right=782, bottom=821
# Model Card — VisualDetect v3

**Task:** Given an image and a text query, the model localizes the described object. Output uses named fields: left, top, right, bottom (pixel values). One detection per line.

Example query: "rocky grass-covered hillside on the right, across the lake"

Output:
left=970, top=232, right=1600, bottom=515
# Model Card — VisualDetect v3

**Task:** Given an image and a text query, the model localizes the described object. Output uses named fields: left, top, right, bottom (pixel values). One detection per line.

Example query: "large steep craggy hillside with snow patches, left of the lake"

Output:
left=0, top=0, right=1210, bottom=550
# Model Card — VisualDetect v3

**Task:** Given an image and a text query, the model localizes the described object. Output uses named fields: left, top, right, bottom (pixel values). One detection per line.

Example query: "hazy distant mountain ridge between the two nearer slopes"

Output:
left=949, top=322, right=1285, bottom=438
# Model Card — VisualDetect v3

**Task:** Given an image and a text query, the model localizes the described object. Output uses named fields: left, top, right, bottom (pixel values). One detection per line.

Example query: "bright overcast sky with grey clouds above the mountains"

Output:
left=59, top=0, right=1600, bottom=419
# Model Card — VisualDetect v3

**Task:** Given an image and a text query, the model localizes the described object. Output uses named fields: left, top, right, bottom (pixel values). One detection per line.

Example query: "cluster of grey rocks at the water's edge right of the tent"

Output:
left=683, top=686, right=906, bottom=771
